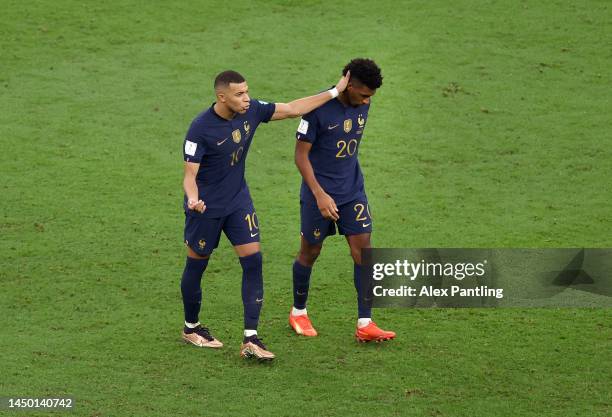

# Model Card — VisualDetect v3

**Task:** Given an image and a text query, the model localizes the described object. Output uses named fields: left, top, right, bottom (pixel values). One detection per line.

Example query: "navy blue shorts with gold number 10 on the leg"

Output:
left=185, top=201, right=259, bottom=256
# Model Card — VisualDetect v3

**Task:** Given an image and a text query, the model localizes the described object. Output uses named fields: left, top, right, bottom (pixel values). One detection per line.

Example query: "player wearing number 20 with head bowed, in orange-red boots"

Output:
left=289, top=58, right=395, bottom=342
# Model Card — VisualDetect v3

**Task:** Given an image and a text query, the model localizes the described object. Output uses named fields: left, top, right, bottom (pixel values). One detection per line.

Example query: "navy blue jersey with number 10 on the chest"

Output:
left=183, top=100, right=276, bottom=217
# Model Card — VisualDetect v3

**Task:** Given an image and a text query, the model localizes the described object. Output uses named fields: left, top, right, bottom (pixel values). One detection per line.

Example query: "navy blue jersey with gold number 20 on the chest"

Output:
left=296, top=98, right=370, bottom=205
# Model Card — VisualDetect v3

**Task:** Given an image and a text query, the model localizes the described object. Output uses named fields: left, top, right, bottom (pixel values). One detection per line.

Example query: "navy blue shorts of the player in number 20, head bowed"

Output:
left=300, top=196, right=372, bottom=245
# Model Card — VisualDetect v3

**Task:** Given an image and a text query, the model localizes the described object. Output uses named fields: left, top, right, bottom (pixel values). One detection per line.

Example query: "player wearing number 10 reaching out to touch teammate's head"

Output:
left=181, top=71, right=350, bottom=360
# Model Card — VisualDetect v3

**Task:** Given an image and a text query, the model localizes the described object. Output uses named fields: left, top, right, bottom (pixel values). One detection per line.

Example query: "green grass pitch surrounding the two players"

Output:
left=0, top=0, right=612, bottom=417
